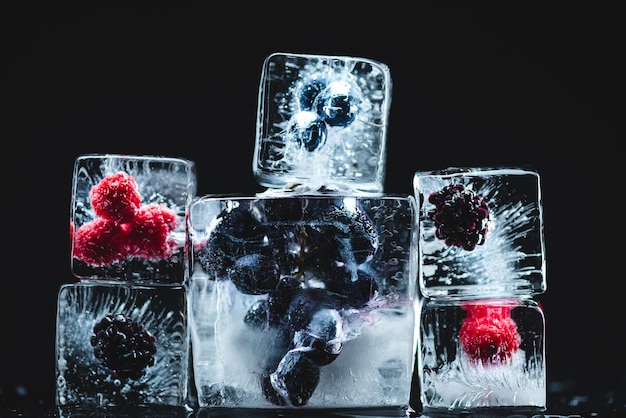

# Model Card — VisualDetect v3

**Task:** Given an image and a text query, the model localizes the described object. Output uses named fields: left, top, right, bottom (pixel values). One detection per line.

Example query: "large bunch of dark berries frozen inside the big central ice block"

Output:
left=198, top=198, right=379, bottom=406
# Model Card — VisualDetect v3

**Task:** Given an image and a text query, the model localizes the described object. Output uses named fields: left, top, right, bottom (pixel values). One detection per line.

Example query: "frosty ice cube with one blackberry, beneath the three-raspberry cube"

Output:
left=56, top=282, right=189, bottom=407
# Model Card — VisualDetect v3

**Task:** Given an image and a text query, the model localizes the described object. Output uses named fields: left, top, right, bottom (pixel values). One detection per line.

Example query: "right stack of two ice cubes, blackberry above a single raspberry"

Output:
left=414, top=168, right=546, bottom=413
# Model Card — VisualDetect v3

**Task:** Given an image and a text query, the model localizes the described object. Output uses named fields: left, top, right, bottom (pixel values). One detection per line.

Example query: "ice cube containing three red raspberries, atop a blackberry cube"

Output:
left=70, top=154, right=196, bottom=284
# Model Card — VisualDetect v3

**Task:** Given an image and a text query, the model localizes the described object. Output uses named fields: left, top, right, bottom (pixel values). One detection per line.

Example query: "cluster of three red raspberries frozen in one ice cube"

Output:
left=70, top=172, right=178, bottom=266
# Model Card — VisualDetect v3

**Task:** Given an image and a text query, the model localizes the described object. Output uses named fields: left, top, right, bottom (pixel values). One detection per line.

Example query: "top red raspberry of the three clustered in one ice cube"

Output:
left=89, top=172, right=141, bottom=223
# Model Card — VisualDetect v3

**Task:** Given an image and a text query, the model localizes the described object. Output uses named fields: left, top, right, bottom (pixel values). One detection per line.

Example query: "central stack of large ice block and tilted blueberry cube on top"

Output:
left=189, top=53, right=417, bottom=415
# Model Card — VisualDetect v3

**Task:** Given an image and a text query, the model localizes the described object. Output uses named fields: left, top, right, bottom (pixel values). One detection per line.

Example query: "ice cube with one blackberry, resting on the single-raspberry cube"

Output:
left=414, top=168, right=546, bottom=297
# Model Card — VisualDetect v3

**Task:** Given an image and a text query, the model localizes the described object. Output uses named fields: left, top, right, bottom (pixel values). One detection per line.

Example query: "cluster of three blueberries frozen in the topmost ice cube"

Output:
left=287, top=74, right=361, bottom=152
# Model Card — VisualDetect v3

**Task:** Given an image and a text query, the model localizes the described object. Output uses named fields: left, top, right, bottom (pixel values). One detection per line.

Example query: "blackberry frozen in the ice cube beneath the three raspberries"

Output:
left=89, top=314, right=157, bottom=379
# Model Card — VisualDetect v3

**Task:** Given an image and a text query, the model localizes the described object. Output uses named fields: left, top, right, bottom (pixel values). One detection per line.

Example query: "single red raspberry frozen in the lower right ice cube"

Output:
left=459, top=305, right=521, bottom=364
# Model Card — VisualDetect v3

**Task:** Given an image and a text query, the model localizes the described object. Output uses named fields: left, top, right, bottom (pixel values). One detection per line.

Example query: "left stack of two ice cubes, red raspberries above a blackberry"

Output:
left=56, top=154, right=196, bottom=416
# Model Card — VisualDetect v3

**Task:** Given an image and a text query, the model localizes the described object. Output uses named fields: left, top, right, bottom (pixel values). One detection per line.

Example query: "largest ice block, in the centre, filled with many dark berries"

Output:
left=189, top=195, right=417, bottom=409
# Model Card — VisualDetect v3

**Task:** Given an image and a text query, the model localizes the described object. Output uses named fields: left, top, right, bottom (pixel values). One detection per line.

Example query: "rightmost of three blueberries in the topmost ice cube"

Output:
left=313, top=81, right=361, bottom=127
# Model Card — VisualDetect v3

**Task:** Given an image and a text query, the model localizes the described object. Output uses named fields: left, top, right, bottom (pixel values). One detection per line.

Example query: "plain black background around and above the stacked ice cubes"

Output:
left=0, top=1, right=626, bottom=414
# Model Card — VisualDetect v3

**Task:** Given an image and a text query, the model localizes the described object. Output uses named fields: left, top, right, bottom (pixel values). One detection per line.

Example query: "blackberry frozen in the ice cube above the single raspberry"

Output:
left=428, top=184, right=489, bottom=251
